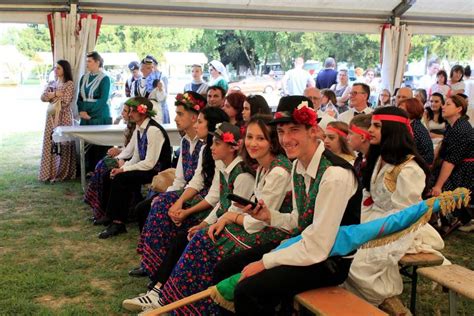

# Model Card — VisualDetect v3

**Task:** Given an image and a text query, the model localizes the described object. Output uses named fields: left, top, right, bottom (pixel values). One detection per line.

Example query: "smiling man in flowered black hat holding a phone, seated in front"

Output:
left=216, top=96, right=362, bottom=315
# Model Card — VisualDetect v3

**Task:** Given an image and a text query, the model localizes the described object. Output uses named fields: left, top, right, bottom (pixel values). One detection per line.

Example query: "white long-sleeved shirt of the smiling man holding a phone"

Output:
left=263, top=141, right=357, bottom=269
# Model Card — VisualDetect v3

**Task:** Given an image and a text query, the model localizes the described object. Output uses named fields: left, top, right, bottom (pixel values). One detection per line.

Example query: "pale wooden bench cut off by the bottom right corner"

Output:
left=418, top=264, right=474, bottom=316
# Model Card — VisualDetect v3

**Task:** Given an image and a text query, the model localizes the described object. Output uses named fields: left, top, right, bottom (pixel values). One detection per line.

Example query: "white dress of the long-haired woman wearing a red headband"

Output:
left=344, top=158, right=444, bottom=305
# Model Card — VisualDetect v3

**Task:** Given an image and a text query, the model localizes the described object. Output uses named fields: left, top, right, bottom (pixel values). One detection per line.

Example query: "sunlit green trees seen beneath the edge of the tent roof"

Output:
left=0, top=24, right=474, bottom=71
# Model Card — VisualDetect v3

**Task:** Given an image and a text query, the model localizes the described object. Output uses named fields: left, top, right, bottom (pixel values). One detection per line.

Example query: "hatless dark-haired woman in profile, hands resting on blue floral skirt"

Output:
left=137, top=107, right=229, bottom=279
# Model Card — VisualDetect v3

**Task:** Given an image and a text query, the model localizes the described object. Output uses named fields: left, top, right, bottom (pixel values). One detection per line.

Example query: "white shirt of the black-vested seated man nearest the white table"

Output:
left=122, top=118, right=165, bottom=172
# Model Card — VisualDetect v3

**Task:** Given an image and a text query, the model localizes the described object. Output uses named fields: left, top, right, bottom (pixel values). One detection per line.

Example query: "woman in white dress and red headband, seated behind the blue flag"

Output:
left=345, top=107, right=444, bottom=305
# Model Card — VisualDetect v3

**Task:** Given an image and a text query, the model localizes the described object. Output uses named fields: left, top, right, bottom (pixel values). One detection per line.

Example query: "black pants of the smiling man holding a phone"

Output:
left=214, top=244, right=352, bottom=316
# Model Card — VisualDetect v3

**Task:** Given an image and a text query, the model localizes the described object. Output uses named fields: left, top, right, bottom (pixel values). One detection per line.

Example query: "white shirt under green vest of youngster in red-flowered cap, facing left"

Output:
left=204, top=156, right=255, bottom=225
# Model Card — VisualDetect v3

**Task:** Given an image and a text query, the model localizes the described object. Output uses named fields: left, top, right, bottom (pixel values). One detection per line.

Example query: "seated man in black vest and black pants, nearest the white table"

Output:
left=99, top=97, right=171, bottom=239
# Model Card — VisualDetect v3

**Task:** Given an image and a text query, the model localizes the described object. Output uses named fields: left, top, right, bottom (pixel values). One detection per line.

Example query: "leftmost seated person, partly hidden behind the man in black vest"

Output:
left=84, top=104, right=136, bottom=225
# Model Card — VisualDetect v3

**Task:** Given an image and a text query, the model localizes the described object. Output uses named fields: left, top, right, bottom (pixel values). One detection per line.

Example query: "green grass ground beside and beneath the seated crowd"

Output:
left=0, top=133, right=474, bottom=315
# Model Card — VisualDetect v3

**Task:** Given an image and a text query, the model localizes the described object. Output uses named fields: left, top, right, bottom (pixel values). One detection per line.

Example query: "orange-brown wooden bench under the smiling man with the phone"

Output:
left=294, top=287, right=387, bottom=316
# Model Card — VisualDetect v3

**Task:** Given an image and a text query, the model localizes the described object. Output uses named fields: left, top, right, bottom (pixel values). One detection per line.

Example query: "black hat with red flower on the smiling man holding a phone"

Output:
left=269, top=95, right=318, bottom=126
